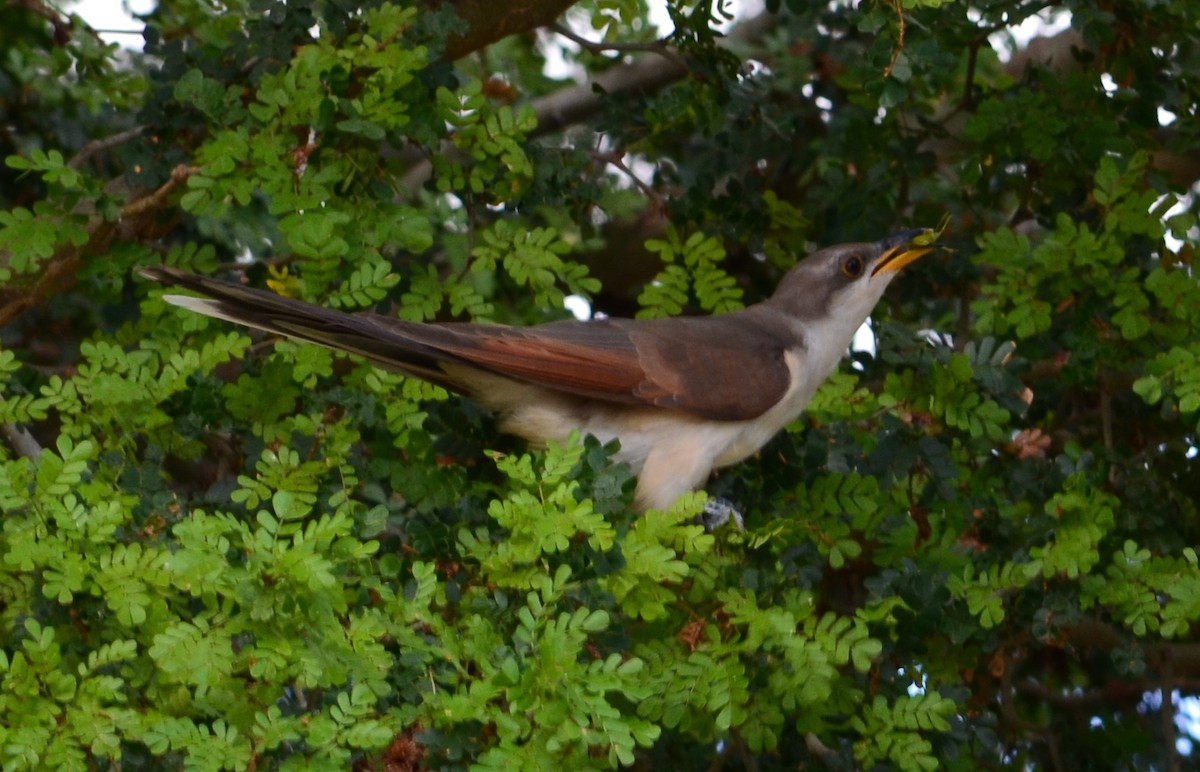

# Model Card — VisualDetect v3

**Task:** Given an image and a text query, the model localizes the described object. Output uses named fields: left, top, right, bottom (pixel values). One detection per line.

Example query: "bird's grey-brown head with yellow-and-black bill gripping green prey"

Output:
left=768, top=228, right=936, bottom=326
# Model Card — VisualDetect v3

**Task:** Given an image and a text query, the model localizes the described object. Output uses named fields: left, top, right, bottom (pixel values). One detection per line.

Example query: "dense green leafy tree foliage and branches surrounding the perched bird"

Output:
left=0, top=0, right=1200, bottom=770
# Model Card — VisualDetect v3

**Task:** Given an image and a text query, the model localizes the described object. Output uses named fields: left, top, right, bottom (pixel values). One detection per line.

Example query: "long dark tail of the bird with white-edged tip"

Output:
left=138, top=267, right=462, bottom=390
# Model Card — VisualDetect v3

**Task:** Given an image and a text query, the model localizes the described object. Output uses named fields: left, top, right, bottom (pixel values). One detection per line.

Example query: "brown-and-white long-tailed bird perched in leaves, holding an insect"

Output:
left=139, top=228, right=936, bottom=511
